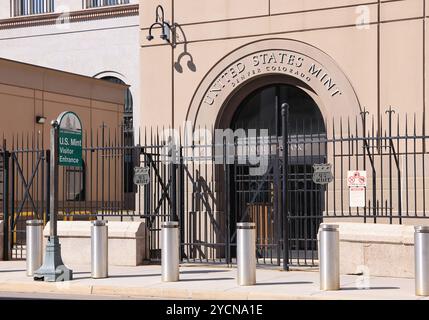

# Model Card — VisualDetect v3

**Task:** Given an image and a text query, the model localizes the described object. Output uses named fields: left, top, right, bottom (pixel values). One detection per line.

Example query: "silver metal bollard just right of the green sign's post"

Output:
left=91, top=220, right=109, bottom=279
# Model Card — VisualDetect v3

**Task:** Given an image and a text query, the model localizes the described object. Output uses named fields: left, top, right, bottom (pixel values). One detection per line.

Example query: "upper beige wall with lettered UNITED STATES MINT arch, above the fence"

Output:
left=140, top=0, right=429, bottom=132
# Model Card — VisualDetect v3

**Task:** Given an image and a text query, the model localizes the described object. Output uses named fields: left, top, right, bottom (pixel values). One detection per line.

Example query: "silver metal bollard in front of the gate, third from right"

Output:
left=237, top=222, right=256, bottom=286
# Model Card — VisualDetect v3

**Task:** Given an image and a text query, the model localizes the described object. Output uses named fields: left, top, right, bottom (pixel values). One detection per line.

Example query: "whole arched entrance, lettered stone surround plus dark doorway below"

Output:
left=182, top=38, right=362, bottom=265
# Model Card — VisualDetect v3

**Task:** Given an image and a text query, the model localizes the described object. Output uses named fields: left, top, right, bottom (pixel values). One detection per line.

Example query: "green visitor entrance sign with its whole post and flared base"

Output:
left=34, top=111, right=82, bottom=282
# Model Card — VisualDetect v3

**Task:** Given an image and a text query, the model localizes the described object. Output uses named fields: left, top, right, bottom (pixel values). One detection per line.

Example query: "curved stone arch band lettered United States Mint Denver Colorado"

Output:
left=186, top=38, right=361, bottom=127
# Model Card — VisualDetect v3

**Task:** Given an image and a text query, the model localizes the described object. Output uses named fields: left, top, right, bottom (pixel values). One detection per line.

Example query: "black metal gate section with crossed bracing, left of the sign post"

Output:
left=1, top=135, right=49, bottom=260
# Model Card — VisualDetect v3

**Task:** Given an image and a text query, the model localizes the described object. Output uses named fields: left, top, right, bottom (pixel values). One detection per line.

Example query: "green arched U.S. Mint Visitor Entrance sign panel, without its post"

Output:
left=58, top=111, right=82, bottom=167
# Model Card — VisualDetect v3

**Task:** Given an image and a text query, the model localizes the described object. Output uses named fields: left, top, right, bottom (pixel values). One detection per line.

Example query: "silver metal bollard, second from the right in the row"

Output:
left=319, top=223, right=340, bottom=290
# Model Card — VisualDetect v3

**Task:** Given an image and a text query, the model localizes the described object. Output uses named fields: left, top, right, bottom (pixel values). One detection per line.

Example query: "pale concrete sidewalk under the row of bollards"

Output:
left=0, top=261, right=429, bottom=300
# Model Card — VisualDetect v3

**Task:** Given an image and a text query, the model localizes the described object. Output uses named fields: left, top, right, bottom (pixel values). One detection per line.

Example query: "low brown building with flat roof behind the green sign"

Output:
left=0, top=59, right=128, bottom=245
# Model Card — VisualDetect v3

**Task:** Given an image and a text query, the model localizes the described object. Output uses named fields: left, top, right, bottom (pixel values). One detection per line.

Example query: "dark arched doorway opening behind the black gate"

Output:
left=222, top=77, right=326, bottom=261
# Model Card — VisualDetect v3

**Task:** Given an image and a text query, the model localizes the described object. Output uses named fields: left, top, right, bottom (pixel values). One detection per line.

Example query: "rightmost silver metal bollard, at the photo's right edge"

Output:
left=414, top=226, right=429, bottom=296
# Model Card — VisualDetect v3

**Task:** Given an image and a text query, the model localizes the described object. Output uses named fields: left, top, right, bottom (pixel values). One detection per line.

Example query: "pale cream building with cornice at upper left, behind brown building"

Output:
left=0, top=0, right=139, bottom=134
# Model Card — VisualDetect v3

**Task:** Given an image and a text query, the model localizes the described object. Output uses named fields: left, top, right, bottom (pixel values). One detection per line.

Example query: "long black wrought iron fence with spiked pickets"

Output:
left=0, top=110, right=429, bottom=268
